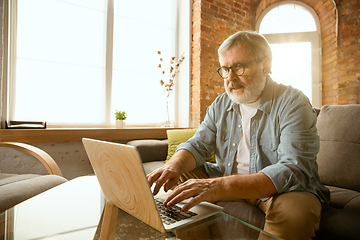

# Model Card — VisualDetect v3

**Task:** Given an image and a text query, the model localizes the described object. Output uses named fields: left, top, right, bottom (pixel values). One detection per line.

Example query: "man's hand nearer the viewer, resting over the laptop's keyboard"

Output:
left=164, top=178, right=223, bottom=211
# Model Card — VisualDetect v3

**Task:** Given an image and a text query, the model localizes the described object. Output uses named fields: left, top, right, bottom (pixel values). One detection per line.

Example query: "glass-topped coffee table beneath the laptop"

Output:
left=0, top=176, right=279, bottom=240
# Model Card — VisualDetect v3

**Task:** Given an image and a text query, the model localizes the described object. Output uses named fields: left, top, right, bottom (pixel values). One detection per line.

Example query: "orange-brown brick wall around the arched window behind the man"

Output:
left=191, top=0, right=360, bottom=126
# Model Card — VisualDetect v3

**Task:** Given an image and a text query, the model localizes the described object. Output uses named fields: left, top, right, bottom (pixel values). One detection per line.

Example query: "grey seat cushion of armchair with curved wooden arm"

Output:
left=0, top=174, right=67, bottom=213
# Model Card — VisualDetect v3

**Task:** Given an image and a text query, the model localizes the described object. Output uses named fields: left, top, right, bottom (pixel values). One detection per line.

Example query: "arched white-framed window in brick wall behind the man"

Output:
left=256, top=1, right=321, bottom=107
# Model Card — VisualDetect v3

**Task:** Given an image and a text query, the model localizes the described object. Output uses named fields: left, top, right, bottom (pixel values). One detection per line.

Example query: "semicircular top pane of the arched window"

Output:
left=259, top=4, right=316, bottom=34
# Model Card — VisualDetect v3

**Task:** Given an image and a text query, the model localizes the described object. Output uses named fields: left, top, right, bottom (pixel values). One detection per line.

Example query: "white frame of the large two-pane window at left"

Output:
left=1, top=0, right=192, bottom=128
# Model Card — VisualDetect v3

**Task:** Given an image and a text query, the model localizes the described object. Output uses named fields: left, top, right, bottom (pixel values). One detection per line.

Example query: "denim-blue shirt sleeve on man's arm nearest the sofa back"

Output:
left=260, top=94, right=320, bottom=194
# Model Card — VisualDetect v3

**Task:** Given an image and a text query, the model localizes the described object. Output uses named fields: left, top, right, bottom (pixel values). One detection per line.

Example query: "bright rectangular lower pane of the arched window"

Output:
left=270, top=42, right=312, bottom=101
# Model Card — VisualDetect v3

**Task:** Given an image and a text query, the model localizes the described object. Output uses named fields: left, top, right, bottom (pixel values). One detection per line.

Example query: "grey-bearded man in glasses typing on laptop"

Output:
left=148, top=31, right=329, bottom=239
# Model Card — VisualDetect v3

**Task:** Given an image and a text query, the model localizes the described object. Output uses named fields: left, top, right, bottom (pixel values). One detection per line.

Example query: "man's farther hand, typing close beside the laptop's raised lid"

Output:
left=147, top=165, right=180, bottom=195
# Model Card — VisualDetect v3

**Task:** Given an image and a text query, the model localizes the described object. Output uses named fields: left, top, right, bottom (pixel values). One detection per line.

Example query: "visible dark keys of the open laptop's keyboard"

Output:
left=155, top=199, right=197, bottom=225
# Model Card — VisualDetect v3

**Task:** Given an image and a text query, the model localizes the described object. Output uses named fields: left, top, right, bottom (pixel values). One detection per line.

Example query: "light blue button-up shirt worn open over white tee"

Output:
left=177, top=77, right=330, bottom=206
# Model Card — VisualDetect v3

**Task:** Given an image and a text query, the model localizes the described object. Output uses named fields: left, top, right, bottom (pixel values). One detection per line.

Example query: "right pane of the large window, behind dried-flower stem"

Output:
left=112, top=0, right=176, bottom=125
